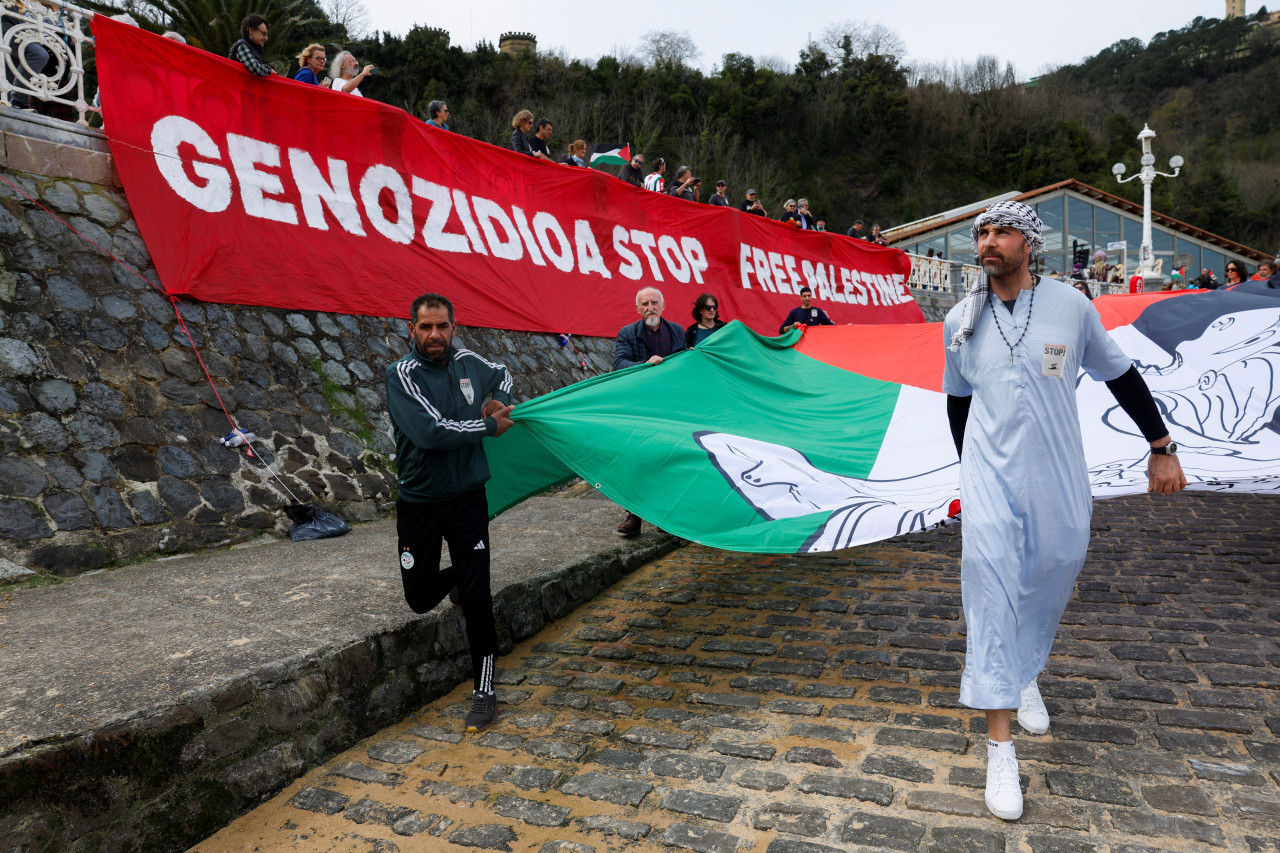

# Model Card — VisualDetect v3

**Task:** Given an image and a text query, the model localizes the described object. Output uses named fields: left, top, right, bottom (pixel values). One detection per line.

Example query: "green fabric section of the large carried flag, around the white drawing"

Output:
left=485, top=323, right=900, bottom=553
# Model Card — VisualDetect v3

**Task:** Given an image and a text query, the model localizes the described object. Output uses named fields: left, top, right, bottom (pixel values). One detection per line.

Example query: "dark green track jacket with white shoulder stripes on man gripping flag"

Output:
left=387, top=347, right=511, bottom=503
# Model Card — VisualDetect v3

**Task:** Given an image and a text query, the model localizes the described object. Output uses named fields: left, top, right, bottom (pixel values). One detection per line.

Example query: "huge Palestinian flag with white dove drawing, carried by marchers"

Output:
left=485, top=289, right=1280, bottom=553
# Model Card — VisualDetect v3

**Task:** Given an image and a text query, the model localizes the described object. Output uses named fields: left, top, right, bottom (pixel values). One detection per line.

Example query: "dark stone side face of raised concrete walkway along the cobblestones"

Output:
left=0, top=498, right=682, bottom=850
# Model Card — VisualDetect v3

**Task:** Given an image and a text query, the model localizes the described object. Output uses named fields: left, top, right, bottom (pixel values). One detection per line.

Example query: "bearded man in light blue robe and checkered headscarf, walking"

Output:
left=942, top=201, right=1187, bottom=820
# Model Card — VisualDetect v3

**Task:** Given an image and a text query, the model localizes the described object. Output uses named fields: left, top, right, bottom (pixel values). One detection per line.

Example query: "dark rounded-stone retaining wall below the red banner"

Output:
left=0, top=154, right=612, bottom=578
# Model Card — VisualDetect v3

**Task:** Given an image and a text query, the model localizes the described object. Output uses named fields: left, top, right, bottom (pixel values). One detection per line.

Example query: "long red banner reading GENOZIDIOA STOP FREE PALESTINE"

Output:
left=93, top=15, right=924, bottom=336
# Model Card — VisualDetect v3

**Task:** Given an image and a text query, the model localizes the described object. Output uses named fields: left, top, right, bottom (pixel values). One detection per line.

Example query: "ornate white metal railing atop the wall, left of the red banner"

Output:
left=0, top=0, right=96, bottom=124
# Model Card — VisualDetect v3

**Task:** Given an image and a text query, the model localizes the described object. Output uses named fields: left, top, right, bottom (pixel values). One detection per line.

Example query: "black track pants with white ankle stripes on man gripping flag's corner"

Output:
left=396, top=487, right=498, bottom=690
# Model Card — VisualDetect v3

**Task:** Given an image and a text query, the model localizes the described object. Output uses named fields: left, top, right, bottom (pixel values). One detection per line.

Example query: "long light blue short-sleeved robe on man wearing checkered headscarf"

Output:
left=942, top=278, right=1132, bottom=710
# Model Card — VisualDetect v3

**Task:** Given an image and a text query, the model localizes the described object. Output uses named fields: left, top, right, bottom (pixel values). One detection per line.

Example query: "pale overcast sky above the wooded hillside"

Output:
left=365, top=0, right=1263, bottom=79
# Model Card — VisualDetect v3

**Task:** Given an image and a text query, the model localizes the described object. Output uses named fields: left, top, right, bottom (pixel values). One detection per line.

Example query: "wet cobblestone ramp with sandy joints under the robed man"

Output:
left=195, top=494, right=1280, bottom=853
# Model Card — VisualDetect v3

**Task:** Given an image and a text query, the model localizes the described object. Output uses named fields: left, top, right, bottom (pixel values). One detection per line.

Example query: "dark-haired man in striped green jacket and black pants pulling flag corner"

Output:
left=387, top=293, right=512, bottom=731
